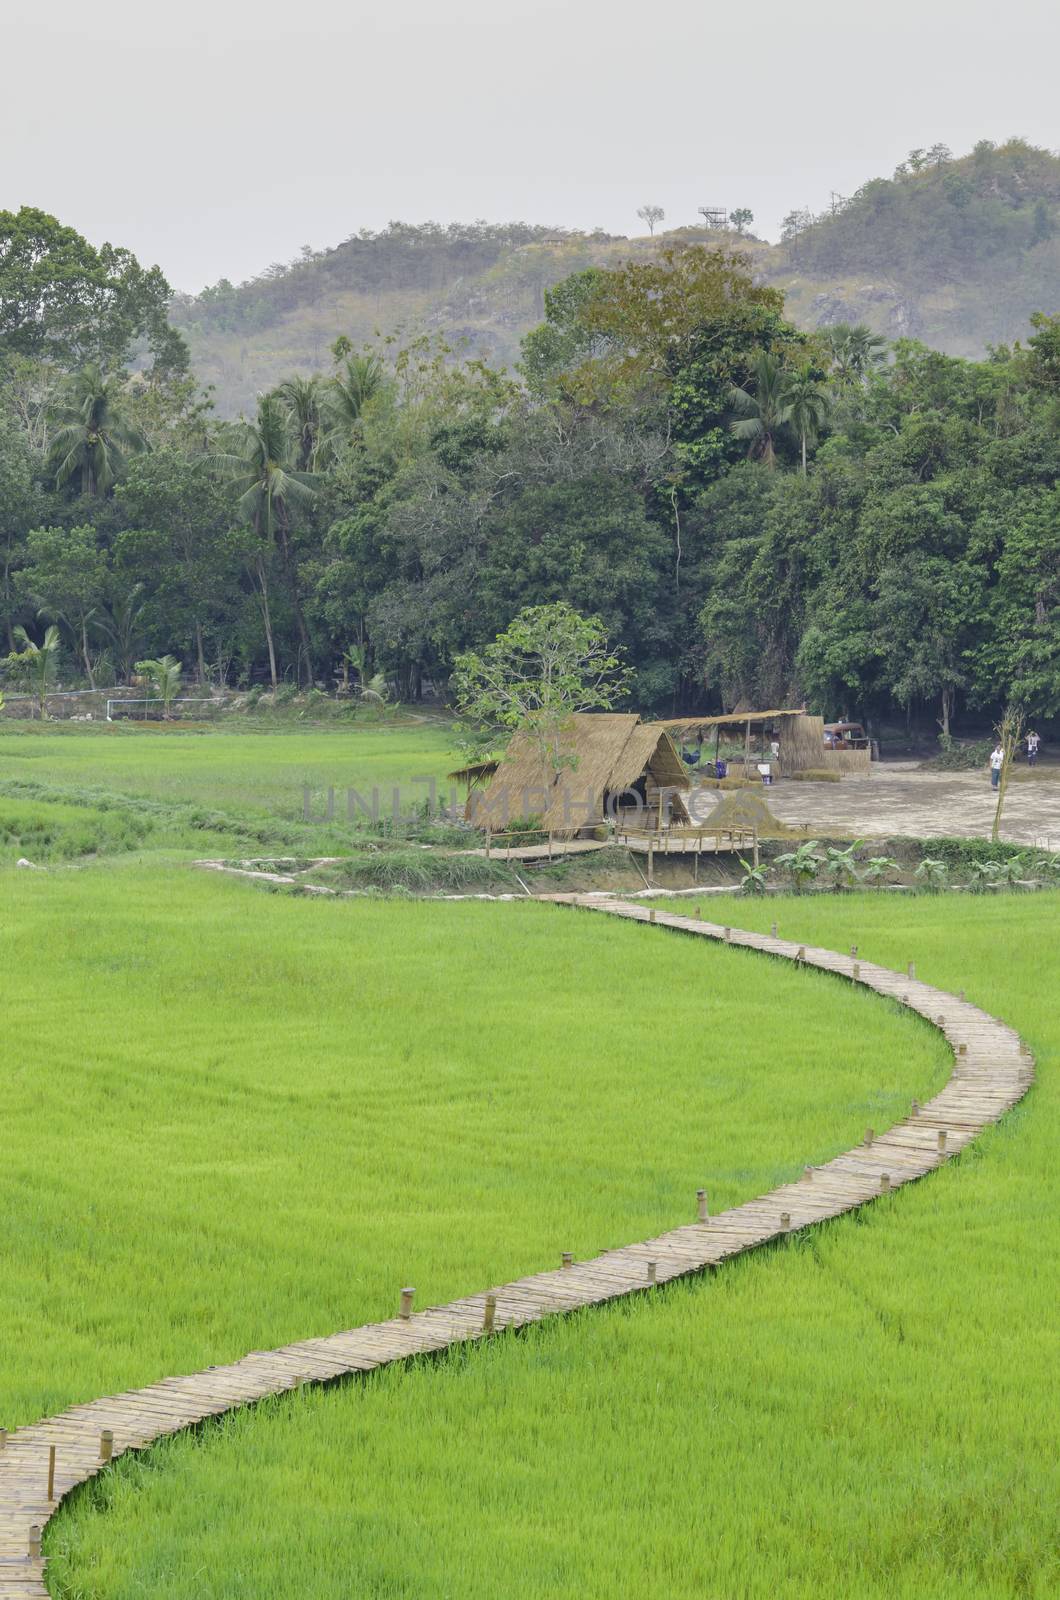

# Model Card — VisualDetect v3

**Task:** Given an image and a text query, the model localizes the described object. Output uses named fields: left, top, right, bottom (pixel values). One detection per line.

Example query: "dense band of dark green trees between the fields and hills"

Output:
left=0, top=211, right=1060, bottom=728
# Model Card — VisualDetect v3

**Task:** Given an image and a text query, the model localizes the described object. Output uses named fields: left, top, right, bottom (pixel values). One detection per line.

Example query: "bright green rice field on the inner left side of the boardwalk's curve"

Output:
left=0, top=864, right=945, bottom=1427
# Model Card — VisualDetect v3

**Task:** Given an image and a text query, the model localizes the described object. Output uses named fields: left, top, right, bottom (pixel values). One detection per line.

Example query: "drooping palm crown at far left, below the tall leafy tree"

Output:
left=48, top=365, right=149, bottom=494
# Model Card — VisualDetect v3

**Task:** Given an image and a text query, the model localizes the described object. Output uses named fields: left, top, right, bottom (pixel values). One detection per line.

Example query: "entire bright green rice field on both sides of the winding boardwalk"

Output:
left=0, top=726, right=1060, bottom=1600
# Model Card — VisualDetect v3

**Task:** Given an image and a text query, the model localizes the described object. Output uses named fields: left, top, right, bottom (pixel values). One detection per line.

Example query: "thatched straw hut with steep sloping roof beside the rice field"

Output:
left=468, top=712, right=690, bottom=835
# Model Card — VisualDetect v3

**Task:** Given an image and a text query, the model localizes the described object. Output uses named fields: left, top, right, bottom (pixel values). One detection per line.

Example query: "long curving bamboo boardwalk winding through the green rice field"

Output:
left=0, top=896, right=1033, bottom=1600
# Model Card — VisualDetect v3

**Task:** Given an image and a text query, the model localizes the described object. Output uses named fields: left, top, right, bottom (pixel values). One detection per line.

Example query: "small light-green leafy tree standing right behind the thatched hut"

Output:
left=453, top=600, right=628, bottom=773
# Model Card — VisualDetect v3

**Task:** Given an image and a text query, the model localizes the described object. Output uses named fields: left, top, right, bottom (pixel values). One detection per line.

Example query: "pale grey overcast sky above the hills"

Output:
left=0, top=0, right=1060, bottom=291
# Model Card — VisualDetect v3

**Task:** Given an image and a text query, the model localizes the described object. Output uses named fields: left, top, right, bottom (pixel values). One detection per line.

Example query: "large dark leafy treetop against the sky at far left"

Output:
left=0, top=206, right=186, bottom=368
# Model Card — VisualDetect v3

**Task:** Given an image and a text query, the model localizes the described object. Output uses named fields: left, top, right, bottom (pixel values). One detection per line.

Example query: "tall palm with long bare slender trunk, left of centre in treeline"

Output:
left=211, top=394, right=315, bottom=682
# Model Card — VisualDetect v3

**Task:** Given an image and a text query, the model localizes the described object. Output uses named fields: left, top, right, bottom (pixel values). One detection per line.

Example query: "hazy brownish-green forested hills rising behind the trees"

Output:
left=171, top=139, right=1060, bottom=416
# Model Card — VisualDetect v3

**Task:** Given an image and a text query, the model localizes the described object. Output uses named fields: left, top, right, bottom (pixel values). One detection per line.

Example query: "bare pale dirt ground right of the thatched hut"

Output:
left=730, top=762, right=1060, bottom=850
